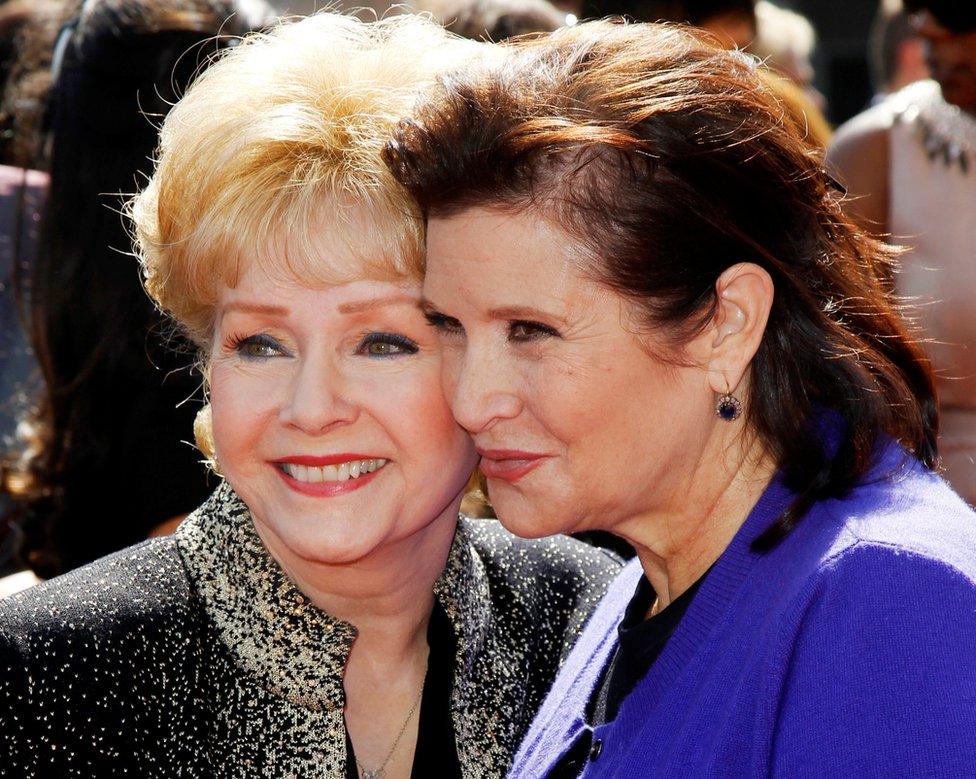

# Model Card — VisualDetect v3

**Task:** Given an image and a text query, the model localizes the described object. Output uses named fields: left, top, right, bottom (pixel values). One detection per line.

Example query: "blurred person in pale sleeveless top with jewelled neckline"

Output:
left=829, top=0, right=976, bottom=503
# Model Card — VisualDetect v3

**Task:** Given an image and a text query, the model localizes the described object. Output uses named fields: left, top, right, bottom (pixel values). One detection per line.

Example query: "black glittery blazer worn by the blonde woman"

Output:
left=0, top=484, right=619, bottom=777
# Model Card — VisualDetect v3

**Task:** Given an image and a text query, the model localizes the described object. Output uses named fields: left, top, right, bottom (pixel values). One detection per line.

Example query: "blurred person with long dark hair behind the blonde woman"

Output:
left=2, top=0, right=272, bottom=596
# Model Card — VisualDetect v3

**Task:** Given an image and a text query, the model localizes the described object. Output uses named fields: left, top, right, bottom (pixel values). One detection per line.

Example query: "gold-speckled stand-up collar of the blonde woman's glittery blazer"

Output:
left=176, top=482, right=491, bottom=711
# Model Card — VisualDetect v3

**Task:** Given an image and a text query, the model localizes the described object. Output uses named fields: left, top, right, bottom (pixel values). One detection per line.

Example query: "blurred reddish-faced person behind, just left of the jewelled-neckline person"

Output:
left=868, top=0, right=929, bottom=104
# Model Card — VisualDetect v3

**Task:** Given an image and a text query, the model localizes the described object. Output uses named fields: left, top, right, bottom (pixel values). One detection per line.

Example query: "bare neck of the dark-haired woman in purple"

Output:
left=614, top=426, right=776, bottom=614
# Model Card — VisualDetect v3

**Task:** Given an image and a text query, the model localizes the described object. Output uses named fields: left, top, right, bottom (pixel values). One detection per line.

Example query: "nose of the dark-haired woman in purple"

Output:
left=444, top=345, right=523, bottom=434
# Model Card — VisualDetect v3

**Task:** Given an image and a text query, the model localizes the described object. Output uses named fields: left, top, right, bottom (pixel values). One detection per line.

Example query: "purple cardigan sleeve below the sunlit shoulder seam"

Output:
left=774, top=541, right=976, bottom=776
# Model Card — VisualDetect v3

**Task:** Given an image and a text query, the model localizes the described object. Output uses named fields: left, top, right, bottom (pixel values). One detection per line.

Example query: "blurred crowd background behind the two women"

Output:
left=0, top=0, right=976, bottom=597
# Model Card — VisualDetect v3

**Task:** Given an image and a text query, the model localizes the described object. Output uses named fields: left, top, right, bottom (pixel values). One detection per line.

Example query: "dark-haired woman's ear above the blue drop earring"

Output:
left=703, top=262, right=774, bottom=394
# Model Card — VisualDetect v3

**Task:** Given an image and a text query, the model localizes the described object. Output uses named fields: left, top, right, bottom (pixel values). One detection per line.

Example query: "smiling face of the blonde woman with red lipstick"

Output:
left=210, top=242, right=476, bottom=564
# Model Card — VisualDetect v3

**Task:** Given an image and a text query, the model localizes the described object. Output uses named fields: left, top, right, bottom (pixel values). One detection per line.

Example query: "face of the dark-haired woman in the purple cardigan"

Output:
left=424, top=209, right=716, bottom=537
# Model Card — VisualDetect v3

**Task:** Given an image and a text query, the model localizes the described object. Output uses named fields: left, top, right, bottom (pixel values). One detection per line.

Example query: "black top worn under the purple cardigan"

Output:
left=547, top=569, right=711, bottom=779
